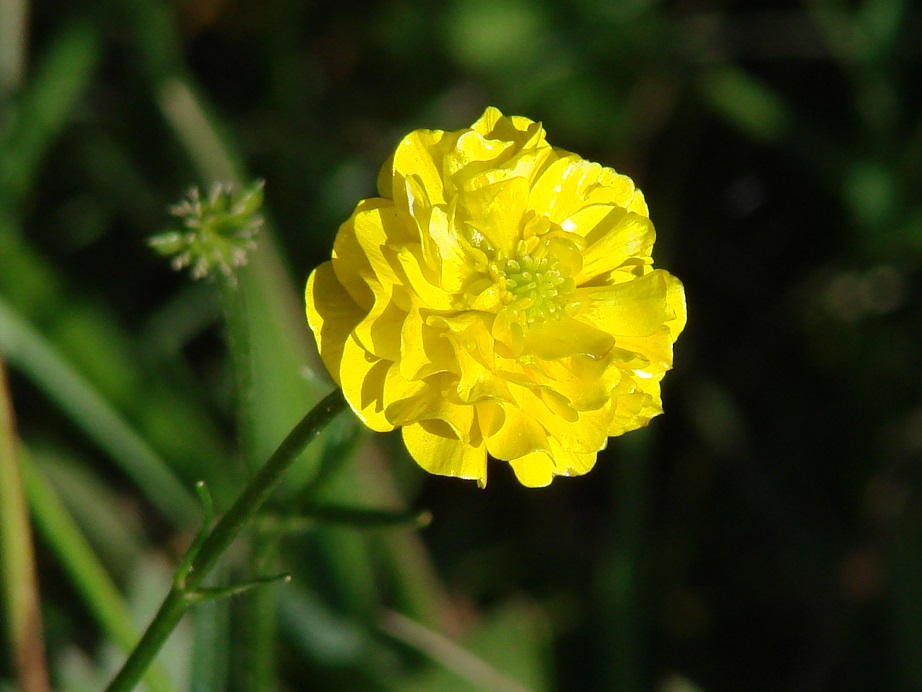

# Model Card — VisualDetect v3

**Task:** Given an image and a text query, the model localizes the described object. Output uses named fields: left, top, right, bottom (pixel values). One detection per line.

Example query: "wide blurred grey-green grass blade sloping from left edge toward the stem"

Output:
left=0, top=299, right=198, bottom=526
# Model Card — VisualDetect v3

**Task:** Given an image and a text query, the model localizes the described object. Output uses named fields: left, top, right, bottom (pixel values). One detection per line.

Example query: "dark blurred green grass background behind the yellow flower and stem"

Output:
left=0, top=0, right=922, bottom=690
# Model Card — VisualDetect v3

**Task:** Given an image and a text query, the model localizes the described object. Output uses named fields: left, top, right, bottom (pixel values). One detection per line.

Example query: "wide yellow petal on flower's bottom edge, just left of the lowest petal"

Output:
left=403, top=421, right=487, bottom=487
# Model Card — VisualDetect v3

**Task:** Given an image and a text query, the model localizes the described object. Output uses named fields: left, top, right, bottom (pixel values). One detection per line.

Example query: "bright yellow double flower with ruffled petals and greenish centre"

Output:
left=306, top=108, right=685, bottom=487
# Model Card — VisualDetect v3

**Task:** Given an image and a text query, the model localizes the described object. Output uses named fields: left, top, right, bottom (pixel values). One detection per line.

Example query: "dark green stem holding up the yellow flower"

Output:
left=108, top=389, right=346, bottom=692
